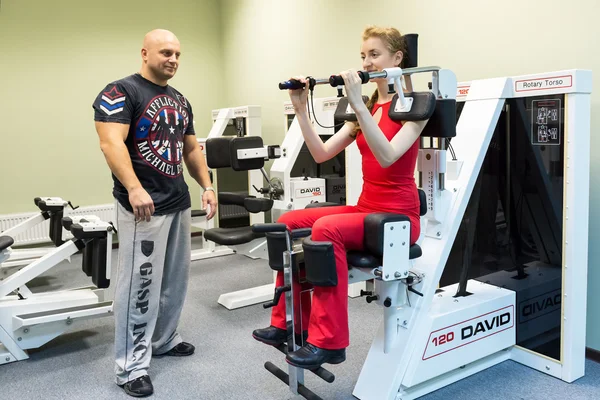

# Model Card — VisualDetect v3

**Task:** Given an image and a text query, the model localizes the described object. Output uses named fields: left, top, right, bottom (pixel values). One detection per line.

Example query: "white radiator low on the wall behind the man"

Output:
left=0, top=203, right=117, bottom=246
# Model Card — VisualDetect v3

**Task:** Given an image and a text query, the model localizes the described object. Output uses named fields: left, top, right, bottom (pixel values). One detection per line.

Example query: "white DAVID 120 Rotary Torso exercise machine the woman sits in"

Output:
left=255, top=34, right=591, bottom=400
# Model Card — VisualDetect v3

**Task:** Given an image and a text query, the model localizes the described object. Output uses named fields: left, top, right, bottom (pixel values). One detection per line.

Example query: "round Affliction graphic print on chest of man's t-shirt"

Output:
left=135, top=95, right=189, bottom=177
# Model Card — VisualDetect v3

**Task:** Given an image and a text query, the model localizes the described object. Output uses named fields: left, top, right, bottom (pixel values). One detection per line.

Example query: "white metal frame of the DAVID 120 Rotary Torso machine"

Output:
left=347, top=70, right=592, bottom=400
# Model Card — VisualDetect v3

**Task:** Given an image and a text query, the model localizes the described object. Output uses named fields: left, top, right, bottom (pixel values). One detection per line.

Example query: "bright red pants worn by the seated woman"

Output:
left=271, top=206, right=420, bottom=350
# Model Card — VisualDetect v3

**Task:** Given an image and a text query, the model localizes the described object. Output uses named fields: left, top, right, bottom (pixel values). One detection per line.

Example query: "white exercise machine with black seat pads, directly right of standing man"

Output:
left=198, top=106, right=278, bottom=310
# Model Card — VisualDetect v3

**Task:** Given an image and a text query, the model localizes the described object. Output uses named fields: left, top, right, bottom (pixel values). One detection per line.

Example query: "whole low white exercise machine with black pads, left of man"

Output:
left=0, top=212, right=113, bottom=364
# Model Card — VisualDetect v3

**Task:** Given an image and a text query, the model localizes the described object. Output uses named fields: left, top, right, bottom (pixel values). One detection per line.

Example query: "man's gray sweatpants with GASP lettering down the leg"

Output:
left=114, top=202, right=192, bottom=385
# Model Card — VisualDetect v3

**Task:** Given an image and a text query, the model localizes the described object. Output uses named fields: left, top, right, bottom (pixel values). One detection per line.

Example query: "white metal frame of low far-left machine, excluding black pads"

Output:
left=0, top=216, right=113, bottom=364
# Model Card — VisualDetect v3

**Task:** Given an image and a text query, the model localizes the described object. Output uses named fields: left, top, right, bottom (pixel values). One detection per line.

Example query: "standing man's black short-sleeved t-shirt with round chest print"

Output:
left=93, top=74, right=195, bottom=215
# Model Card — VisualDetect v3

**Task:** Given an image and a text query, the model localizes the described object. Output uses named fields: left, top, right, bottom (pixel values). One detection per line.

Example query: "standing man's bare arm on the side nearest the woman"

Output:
left=183, top=135, right=217, bottom=219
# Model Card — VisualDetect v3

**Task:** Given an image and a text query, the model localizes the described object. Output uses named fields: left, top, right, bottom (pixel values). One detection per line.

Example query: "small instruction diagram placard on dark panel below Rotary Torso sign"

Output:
left=531, top=99, right=562, bottom=146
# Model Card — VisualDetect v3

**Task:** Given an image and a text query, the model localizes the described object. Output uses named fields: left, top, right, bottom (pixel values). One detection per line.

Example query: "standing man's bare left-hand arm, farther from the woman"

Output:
left=96, top=121, right=154, bottom=221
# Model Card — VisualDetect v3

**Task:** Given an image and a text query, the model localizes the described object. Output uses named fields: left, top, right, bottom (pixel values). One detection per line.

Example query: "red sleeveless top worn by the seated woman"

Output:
left=356, top=101, right=420, bottom=242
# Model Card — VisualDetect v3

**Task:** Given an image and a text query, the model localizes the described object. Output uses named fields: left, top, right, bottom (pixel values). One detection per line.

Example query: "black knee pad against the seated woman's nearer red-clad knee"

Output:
left=302, top=237, right=337, bottom=286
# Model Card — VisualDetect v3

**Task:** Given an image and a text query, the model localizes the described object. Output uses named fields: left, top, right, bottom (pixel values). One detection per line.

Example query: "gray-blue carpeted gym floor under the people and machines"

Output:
left=0, top=242, right=600, bottom=400
